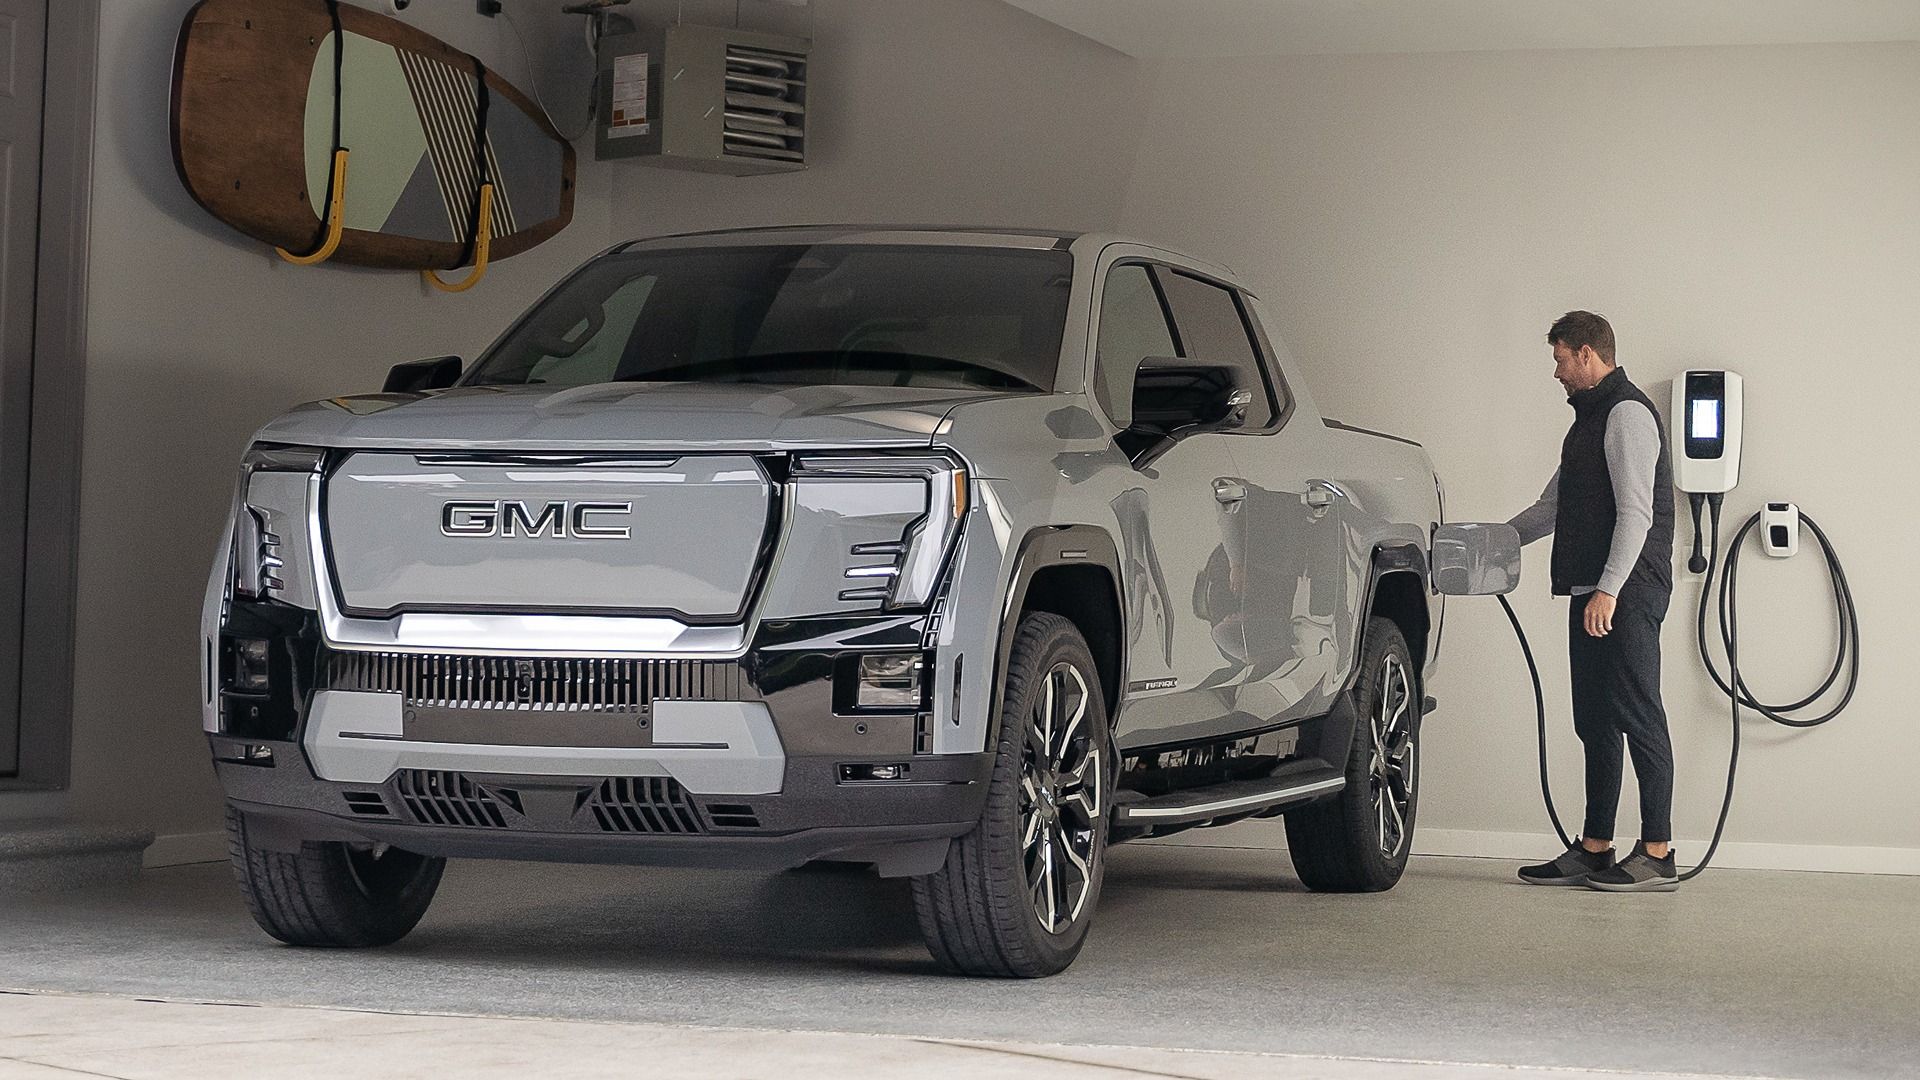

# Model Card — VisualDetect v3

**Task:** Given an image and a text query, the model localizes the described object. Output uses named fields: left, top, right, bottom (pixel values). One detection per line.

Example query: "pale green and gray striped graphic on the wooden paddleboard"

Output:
left=305, top=33, right=564, bottom=244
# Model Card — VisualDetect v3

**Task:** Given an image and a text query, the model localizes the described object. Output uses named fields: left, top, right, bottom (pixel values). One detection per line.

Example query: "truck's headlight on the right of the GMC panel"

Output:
left=793, top=454, right=968, bottom=609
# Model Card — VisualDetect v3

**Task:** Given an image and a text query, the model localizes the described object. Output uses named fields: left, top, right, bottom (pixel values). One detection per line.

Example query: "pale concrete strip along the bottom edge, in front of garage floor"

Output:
left=0, top=994, right=1758, bottom=1080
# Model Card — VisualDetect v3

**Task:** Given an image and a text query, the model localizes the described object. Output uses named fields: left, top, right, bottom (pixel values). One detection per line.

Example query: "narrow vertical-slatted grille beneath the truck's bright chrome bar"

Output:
left=323, top=651, right=749, bottom=713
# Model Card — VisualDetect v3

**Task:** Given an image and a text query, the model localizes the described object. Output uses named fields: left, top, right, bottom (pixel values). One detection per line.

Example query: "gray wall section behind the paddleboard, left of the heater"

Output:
left=38, top=0, right=609, bottom=836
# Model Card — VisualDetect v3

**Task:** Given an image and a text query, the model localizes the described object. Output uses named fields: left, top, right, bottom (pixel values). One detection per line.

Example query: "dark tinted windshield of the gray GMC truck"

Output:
left=465, top=244, right=1073, bottom=392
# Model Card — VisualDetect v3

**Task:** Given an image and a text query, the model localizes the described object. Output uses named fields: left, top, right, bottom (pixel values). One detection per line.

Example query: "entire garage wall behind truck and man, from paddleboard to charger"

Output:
left=45, top=0, right=1920, bottom=869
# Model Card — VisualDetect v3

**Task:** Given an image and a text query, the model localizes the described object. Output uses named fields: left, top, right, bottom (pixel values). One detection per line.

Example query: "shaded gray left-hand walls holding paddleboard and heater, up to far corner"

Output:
left=30, top=0, right=1142, bottom=859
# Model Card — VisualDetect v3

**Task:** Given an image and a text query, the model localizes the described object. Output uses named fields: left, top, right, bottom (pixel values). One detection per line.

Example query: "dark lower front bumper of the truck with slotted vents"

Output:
left=209, top=736, right=993, bottom=876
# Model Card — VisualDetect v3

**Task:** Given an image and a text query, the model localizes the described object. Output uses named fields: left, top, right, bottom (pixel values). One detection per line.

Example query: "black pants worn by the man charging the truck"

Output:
left=1567, top=582, right=1674, bottom=844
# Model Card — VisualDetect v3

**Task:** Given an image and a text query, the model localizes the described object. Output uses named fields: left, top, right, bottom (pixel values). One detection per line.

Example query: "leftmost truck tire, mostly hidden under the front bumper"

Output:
left=227, top=807, right=447, bottom=949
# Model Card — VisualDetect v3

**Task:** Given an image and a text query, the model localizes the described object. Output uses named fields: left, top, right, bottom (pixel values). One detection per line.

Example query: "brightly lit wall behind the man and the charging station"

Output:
left=1123, top=44, right=1920, bottom=872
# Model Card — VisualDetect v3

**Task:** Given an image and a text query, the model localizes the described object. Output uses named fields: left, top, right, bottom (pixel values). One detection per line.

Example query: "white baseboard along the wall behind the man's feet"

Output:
left=1152, top=819, right=1920, bottom=876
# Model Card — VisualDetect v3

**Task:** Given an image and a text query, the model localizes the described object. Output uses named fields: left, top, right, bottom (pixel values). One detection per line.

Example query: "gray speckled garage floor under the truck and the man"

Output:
left=0, top=832, right=1920, bottom=1076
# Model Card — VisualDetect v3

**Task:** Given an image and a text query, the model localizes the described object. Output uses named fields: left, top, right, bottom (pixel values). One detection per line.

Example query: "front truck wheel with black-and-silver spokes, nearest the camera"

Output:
left=914, top=611, right=1114, bottom=978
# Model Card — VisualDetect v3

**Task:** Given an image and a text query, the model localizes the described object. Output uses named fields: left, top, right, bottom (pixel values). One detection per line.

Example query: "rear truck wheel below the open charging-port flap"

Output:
left=1286, top=617, right=1423, bottom=892
